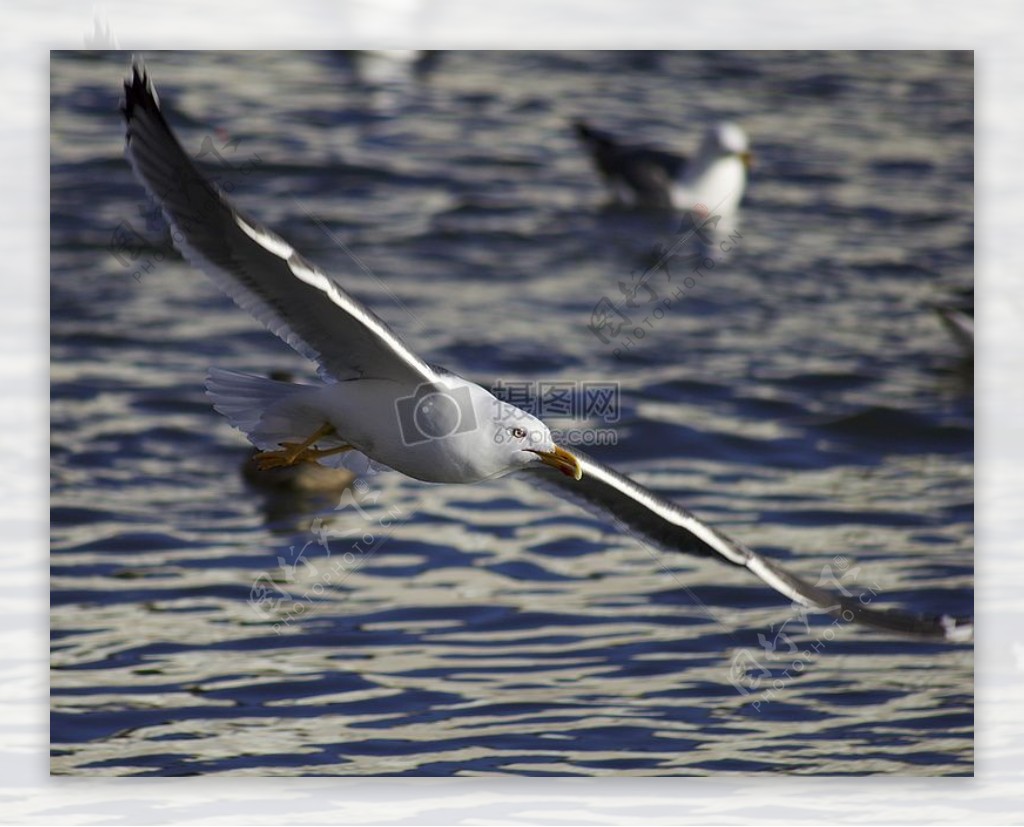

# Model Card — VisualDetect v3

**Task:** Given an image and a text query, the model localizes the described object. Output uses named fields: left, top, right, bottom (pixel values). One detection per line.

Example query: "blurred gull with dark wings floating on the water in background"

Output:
left=574, top=122, right=751, bottom=225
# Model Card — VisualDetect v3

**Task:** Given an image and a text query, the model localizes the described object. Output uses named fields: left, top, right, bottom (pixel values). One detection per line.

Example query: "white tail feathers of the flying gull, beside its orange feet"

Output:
left=206, top=367, right=389, bottom=476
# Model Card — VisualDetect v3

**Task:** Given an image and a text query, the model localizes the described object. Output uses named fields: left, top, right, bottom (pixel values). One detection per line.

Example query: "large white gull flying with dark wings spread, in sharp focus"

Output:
left=124, top=67, right=970, bottom=639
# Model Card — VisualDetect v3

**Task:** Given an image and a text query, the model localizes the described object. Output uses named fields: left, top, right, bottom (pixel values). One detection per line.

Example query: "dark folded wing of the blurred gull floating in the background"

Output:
left=573, top=121, right=687, bottom=207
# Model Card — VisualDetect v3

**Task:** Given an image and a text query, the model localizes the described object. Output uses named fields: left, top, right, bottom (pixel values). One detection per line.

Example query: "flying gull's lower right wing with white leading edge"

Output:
left=531, top=448, right=973, bottom=641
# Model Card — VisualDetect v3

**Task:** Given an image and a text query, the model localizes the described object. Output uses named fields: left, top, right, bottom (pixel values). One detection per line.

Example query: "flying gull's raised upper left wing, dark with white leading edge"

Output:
left=122, top=63, right=436, bottom=383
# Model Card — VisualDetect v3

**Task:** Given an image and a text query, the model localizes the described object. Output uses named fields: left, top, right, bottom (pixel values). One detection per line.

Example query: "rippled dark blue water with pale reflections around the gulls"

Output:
left=51, top=52, right=974, bottom=775
